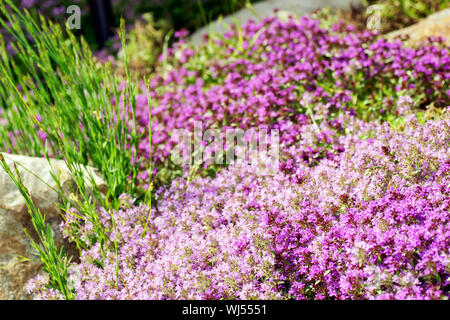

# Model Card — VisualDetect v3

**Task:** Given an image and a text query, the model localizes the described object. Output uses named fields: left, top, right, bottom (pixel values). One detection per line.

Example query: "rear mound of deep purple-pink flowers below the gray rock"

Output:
left=126, top=16, right=450, bottom=184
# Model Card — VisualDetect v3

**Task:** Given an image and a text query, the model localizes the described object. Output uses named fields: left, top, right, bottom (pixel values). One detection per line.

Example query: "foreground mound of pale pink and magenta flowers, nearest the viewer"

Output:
left=32, top=111, right=450, bottom=299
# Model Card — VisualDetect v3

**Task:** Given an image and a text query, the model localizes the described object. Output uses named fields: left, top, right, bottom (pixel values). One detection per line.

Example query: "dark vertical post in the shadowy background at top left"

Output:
left=89, top=0, right=114, bottom=49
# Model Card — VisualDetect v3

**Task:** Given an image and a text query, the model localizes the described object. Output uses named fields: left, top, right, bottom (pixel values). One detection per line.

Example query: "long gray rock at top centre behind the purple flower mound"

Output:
left=191, top=0, right=362, bottom=44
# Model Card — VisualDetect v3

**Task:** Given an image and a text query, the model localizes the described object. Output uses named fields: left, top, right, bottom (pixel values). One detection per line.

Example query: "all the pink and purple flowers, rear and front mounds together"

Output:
left=25, top=13, right=450, bottom=299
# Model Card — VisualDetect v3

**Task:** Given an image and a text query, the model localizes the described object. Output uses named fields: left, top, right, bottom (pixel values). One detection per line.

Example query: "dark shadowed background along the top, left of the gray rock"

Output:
left=6, top=0, right=256, bottom=50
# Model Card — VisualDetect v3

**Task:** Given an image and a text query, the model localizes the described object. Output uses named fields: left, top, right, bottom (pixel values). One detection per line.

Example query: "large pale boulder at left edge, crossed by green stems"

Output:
left=0, top=153, right=107, bottom=299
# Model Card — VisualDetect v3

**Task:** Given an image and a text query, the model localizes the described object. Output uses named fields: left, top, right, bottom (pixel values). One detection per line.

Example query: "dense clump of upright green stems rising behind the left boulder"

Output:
left=0, top=1, right=139, bottom=204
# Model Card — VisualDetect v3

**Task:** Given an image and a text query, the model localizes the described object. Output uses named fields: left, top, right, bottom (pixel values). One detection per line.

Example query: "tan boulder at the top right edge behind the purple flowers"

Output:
left=386, top=8, right=450, bottom=46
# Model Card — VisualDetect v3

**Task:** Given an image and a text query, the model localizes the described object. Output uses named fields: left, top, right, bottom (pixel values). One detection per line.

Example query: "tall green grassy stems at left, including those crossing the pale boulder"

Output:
left=0, top=0, right=151, bottom=299
